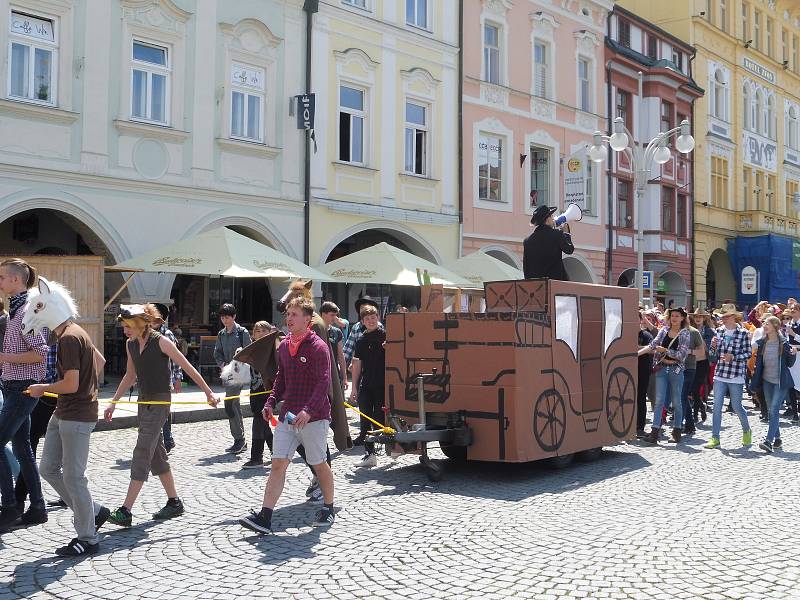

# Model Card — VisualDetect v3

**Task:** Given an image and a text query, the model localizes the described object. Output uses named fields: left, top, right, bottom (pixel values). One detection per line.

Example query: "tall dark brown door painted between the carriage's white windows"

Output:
left=578, top=297, right=604, bottom=418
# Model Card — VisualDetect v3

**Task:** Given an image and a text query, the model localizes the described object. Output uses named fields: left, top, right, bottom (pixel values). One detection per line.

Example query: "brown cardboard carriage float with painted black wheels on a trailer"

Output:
left=372, top=279, right=639, bottom=481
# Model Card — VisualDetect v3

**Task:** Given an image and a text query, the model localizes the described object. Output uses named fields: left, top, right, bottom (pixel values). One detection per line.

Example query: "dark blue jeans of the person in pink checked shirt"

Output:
left=0, top=383, right=44, bottom=508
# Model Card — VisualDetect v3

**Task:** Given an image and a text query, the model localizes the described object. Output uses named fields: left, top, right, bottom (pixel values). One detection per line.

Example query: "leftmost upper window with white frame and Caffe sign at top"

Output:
left=8, top=11, right=58, bottom=104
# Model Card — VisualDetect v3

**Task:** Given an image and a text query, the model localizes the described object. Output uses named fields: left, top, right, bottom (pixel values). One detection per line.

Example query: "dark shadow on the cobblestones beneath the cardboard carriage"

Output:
left=345, top=450, right=651, bottom=501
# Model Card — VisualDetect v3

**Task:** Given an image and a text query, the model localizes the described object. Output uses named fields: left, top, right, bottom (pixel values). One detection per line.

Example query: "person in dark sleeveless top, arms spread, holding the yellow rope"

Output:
left=105, top=304, right=218, bottom=527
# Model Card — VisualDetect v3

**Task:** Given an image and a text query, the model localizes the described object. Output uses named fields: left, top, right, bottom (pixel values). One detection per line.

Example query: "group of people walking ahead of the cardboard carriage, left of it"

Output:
left=0, top=259, right=386, bottom=556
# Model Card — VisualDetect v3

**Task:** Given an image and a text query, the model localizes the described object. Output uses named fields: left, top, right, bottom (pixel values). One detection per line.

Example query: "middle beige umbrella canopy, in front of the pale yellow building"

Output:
left=320, top=242, right=472, bottom=287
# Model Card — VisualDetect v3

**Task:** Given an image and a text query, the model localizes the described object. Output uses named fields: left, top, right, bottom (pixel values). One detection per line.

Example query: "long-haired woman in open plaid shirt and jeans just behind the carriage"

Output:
left=639, top=308, right=690, bottom=444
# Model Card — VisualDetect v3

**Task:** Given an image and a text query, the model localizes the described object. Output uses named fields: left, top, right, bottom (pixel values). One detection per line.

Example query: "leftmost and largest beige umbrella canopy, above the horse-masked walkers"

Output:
left=108, top=227, right=333, bottom=281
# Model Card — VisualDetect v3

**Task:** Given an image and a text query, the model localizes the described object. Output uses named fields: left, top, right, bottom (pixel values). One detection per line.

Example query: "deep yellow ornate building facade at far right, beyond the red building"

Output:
left=618, top=0, right=800, bottom=306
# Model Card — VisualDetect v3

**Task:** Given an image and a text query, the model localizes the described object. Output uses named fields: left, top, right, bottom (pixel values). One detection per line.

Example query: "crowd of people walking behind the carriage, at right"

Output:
left=636, top=298, right=800, bottom=453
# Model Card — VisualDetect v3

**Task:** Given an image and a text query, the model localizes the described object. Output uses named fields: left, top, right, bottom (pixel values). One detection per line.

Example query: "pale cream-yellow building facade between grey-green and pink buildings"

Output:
left=310, top=0, right=459, bottom=314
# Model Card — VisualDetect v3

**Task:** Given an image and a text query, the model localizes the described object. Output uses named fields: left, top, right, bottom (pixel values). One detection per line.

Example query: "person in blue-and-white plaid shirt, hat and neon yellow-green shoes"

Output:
left=704, top=304, right=753, bottom=448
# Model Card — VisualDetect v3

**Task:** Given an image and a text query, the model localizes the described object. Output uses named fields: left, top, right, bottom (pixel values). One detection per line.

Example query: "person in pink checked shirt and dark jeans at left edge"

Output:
left=0, top=258, right=50, bottom=531
